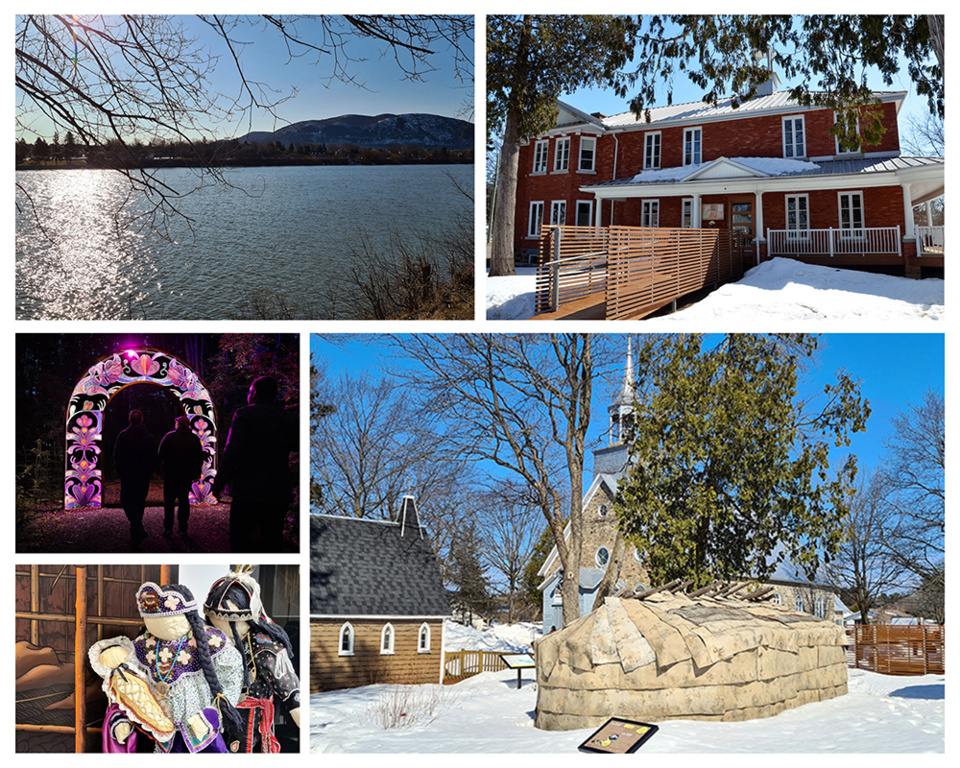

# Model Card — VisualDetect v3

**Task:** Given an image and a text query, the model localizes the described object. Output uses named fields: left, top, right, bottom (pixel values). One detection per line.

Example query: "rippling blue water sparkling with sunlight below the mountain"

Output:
left=16, top=166, right=473, bottom=320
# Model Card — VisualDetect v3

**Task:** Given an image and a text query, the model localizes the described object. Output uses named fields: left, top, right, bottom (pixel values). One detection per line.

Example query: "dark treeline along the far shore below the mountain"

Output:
left=16, top=132, right=473, bottom=169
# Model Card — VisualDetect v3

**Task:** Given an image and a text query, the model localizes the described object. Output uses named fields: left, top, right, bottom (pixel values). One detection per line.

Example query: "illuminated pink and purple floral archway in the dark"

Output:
left=63, top=347, right=217, bottom=509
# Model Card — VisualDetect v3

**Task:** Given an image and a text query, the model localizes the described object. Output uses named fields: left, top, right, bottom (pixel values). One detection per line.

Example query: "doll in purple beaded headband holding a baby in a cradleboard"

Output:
left=90, top=582, right=243, bottom=753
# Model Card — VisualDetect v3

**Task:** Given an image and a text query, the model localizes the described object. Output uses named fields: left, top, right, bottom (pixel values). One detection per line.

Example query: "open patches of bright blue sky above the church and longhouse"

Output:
left=310, top=333, right=944, bottom=480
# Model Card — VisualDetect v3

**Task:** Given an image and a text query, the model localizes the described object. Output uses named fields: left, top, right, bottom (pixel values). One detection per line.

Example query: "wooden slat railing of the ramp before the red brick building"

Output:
left=535, top=226, right=745, bottom=320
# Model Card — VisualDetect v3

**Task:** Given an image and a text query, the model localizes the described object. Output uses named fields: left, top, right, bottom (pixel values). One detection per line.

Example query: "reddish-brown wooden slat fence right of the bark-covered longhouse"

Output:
left=847, top=624, right=946, bottom=675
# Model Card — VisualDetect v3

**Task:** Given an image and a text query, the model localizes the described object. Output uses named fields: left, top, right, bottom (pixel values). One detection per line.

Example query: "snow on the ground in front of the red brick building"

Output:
left=487, top=258, right=944, bottom=320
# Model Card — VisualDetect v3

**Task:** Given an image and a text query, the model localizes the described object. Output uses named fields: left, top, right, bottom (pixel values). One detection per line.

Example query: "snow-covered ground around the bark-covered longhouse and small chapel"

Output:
left=310, top=622, right=946, bottom=755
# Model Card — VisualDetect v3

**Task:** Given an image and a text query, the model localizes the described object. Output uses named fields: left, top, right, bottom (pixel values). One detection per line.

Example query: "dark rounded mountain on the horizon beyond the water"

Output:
left=238, top=113, right=474, bottom=149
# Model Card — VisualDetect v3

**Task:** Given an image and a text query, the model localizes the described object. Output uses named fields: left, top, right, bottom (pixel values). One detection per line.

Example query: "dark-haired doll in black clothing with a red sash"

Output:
left=203, top=570, right=300, bottom=753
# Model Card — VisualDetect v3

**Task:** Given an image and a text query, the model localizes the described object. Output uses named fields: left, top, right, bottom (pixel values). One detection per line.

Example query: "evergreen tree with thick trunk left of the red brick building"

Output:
left=487, top=15, right=635, bottom=276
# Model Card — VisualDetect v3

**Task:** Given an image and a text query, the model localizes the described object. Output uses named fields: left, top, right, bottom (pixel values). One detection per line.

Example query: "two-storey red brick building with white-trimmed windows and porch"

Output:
left=516, top=67, right=944, bottom=272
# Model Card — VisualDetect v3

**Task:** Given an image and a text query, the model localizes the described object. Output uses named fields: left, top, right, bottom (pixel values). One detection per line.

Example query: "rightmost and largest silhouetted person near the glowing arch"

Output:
left=213, top=376, right=299, bottom=552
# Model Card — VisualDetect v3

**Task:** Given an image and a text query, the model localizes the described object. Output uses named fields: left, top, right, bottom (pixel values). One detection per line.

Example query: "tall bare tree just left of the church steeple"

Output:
left=397, top=334, right=594, bottom=623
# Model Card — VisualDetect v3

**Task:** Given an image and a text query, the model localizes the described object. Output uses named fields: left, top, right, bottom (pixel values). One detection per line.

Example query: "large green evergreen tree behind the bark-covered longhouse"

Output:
left=617, top=334, right=870, bottom=585
